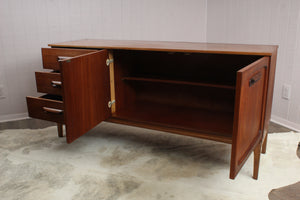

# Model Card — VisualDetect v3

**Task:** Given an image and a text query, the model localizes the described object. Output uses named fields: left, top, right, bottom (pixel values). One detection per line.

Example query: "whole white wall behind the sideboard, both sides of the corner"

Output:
left=0, top=0, right=300, bottom=130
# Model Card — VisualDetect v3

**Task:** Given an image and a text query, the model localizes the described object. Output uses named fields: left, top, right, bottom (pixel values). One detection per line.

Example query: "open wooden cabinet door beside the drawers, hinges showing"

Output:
left=60, top=50, right=111, bottom=143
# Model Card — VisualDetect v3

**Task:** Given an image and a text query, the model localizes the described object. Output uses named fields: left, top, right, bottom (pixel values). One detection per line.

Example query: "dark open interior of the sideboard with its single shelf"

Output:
left=113, top=50, right=261, bottom=137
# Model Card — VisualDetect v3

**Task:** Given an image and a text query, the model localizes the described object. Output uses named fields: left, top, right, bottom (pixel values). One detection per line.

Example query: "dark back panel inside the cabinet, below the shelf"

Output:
left=128, top=82, right=235, bottom=112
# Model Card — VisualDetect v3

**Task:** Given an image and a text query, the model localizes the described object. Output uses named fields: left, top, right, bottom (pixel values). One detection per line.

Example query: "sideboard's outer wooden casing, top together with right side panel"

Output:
left=49, top=39, right=278, bottom=163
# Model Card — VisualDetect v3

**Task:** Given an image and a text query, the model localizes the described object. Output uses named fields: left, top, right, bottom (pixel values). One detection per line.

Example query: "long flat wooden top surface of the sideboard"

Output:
left=49, top=39, right=278, bottom=56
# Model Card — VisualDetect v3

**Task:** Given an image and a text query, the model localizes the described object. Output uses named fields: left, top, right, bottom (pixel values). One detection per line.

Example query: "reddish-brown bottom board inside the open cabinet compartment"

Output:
left=110, top=102, right=233, bottom=143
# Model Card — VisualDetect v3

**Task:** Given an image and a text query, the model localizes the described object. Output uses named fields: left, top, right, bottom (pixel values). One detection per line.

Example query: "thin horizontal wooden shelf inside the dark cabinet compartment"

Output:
left=122, top=77, right=235, bottom=90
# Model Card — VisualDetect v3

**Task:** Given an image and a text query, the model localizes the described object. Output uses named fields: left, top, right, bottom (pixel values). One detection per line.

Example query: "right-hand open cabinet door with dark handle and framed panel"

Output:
left=230, top=57, right=269, bottom=179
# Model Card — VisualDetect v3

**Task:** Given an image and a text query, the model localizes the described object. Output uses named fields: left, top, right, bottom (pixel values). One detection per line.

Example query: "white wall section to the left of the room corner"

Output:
left=0, top=0, right=207, bottom=121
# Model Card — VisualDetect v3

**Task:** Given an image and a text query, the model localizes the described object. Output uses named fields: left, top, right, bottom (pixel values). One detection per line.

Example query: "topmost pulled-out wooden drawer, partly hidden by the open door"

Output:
left=42, top=48, right=95, bottom=70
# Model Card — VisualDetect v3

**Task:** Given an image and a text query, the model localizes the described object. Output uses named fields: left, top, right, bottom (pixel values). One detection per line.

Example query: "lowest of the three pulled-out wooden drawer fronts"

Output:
left=26, top=97, right=64, bottom=124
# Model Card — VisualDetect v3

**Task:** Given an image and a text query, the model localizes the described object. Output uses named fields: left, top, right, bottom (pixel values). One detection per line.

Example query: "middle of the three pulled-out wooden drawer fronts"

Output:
left=35, top=72, right=62, bottom=95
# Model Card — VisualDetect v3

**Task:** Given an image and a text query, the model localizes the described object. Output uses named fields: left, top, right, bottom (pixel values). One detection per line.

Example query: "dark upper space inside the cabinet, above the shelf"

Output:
left=114, top=50, right=261, bottom=85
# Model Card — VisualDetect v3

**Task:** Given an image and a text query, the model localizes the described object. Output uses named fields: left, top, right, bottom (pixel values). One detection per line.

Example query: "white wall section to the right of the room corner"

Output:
left=207, top=0, right=300, bottom=130
